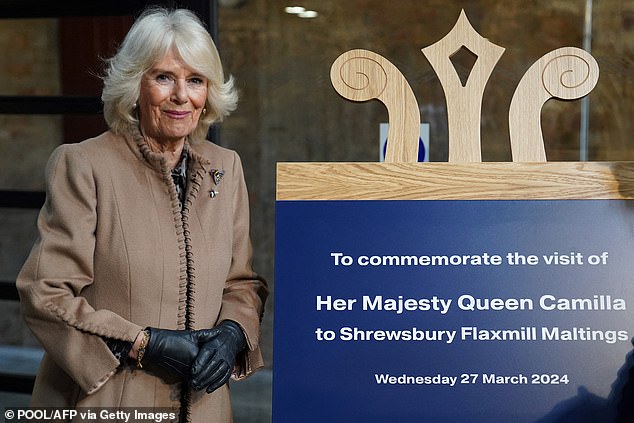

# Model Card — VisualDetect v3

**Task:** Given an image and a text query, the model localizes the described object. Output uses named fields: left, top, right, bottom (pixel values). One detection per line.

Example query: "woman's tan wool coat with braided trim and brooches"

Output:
left=17, top=132, right=267, bottom=423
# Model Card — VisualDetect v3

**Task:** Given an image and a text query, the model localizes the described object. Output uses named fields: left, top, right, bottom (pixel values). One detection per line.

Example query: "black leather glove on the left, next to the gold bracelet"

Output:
left=141, top=328, right=198, bottom=380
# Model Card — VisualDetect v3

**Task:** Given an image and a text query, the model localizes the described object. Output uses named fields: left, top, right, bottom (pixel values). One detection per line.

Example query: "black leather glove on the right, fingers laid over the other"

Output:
left=191, top=320, right=246, bottom=394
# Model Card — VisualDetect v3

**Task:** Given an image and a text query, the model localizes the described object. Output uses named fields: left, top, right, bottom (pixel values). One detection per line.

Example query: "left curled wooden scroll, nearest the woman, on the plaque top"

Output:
left=330, top=49, right=420, bottom=163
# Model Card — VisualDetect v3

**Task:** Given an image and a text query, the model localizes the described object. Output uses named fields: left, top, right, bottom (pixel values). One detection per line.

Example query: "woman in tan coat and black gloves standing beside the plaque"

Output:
left=17, top=9, right=267, bottom=422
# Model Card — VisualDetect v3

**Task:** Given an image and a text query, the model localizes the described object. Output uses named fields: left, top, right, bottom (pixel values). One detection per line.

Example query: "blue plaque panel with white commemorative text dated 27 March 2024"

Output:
left=273, top=200, right=634, bottom=423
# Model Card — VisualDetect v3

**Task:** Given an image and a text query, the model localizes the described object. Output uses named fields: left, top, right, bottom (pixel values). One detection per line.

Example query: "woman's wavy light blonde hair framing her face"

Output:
left=101, top=7, right=238, bottom=140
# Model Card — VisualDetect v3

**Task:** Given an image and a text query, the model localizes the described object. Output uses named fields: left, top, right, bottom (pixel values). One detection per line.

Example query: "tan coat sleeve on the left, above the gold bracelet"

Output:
left=16, top=145, right=142, bottom=394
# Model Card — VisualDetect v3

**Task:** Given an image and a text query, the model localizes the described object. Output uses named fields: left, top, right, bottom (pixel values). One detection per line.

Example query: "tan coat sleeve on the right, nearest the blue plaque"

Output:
left=218, top=153, right=268, bottom=379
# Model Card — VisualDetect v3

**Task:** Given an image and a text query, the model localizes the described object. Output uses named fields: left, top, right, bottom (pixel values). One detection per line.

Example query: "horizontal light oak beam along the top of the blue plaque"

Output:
left=277, top=162, right=634, bottom=200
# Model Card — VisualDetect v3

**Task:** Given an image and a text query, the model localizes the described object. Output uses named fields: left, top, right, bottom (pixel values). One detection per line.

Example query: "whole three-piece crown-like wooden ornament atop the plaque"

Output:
left=330, top=10, right=599, bottom=163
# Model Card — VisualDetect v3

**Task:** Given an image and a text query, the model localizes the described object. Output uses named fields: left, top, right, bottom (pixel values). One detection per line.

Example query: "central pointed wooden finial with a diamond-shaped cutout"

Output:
left=422, top=10, right=504, bottom=162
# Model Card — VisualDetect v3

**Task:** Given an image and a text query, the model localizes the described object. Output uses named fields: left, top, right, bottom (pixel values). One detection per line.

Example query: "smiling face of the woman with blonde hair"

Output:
left=138, top=49, right=207, bottom=144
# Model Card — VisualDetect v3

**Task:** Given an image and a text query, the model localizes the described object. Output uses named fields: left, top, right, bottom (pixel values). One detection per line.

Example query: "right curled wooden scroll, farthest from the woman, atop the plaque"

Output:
left=509, top=47, right=599, bottom=162
